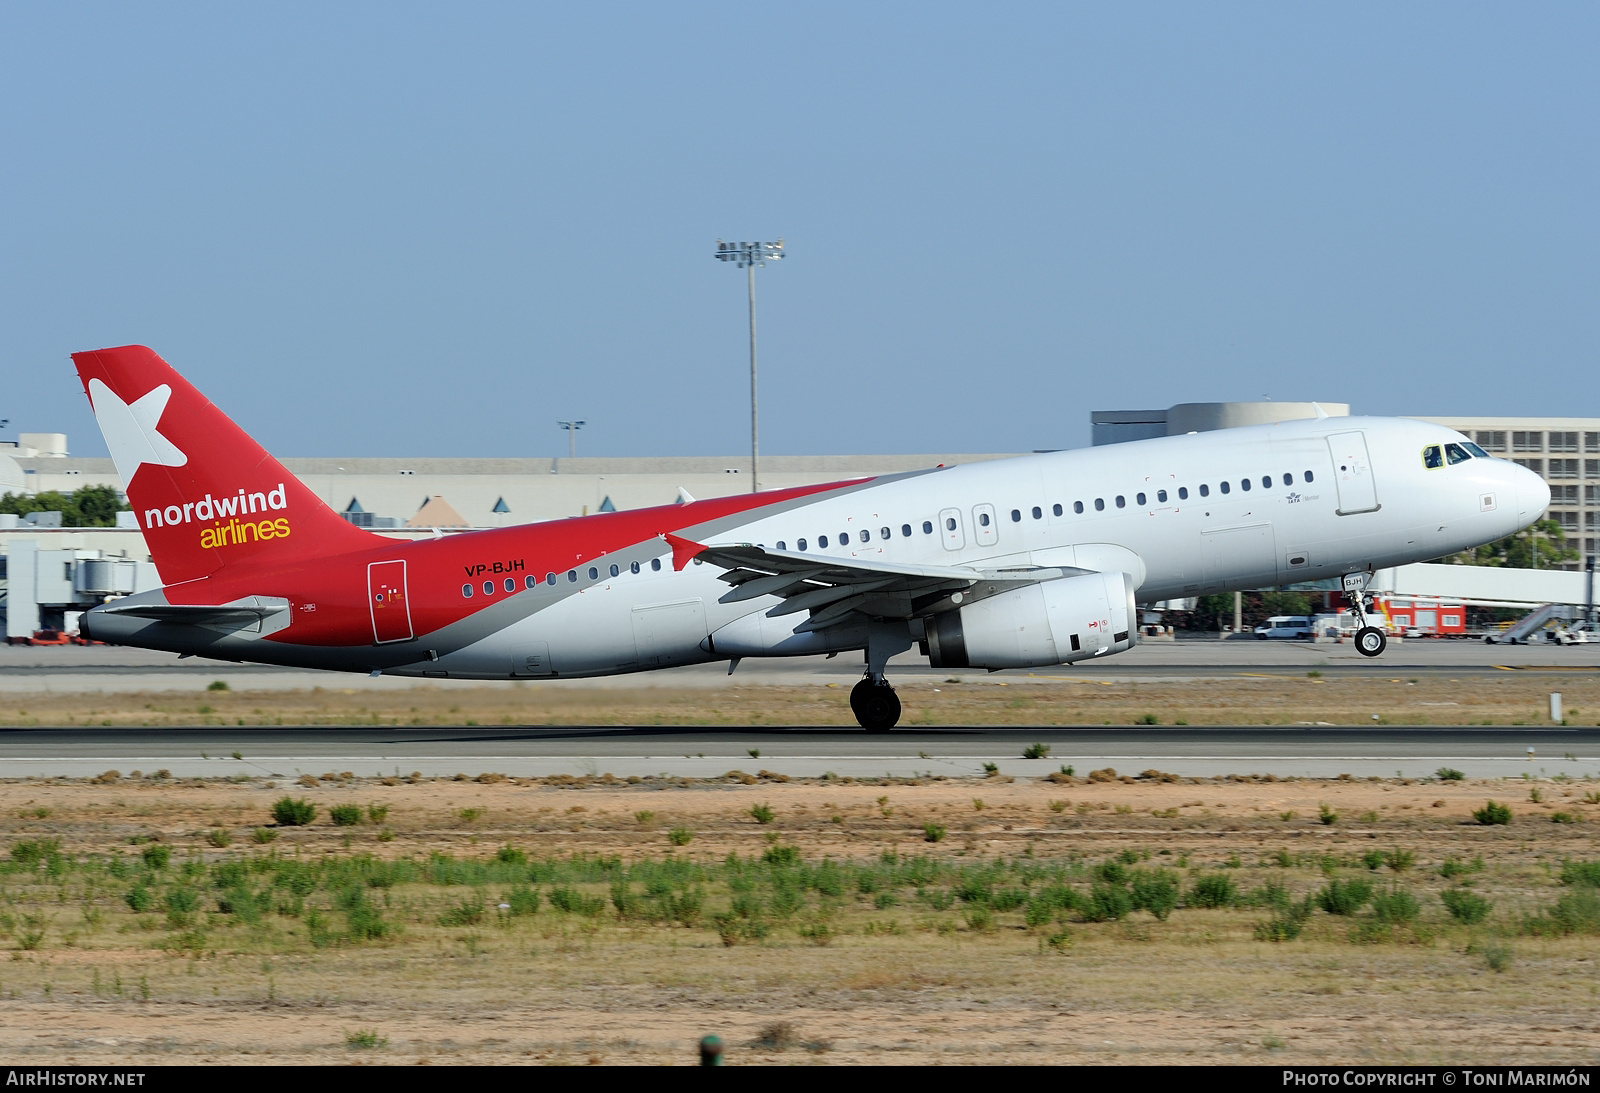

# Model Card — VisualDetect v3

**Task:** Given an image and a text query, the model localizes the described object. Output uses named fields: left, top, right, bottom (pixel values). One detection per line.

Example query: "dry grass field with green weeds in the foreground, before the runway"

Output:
left=0, top=764, right=1600, bottom=1064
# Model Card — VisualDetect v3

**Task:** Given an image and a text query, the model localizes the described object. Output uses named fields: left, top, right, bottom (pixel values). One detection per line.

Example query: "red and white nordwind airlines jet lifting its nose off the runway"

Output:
left=74, top=346, right=1550, bottom=731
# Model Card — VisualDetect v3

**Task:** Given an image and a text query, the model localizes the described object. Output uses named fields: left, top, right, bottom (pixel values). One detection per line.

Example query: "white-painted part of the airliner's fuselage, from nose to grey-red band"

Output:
left=425, top=418, right=1549, bottom=679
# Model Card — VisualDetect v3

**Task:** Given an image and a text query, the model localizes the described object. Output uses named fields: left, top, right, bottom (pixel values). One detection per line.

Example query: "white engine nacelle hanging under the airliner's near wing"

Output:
left=923, top=573, right=1139, bottom=667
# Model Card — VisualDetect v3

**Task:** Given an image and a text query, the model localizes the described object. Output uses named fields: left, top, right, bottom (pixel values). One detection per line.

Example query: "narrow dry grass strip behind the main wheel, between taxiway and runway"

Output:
left=9, top=669, right=1600, bottom=727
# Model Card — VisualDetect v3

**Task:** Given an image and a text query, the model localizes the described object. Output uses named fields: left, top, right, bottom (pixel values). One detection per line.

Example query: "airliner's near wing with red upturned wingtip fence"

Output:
left=667, top=534, right=1088, bottom=632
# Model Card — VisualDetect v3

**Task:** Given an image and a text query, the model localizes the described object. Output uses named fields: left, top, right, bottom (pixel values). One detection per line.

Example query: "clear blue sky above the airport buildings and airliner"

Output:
left=0, top=3, right=1600, bottom=456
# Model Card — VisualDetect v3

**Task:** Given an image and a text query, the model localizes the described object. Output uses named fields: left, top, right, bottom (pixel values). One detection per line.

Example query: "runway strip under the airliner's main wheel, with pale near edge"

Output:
left=0, top=727, right=1600, bottom=779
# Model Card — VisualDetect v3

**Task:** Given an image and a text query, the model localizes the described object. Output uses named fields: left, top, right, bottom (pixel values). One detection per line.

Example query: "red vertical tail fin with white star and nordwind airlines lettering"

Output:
left=72, top=346, right=371, bottom=584
